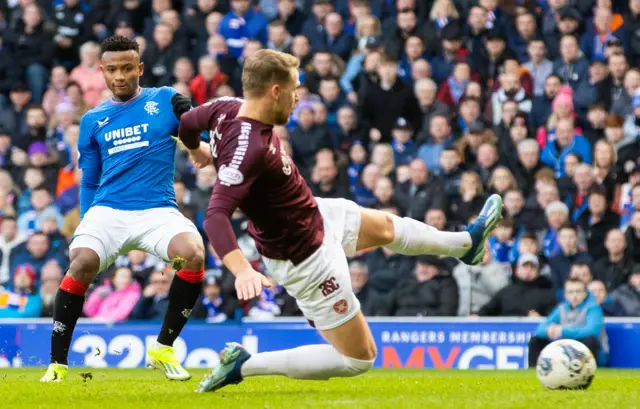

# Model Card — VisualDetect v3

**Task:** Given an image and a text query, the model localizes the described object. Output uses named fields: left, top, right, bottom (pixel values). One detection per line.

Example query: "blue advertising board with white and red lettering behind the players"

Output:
left=0, top=318, right=640, bottom=369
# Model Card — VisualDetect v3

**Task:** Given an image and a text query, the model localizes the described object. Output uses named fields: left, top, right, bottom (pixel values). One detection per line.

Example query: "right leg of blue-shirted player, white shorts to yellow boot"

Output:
left=141, top=208, right=204, bottom=381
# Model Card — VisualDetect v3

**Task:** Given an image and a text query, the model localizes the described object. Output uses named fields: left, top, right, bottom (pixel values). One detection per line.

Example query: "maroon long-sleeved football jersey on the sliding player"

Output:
left=180, top=98, right=324, bottom=264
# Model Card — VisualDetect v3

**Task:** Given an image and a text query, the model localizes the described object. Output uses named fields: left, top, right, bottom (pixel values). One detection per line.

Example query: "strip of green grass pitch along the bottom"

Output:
left=0, top=368, right=640, bottom=409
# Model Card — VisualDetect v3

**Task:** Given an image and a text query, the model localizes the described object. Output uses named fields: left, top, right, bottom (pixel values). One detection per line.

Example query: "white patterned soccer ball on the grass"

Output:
left=536, top=339, right=597, bottom=389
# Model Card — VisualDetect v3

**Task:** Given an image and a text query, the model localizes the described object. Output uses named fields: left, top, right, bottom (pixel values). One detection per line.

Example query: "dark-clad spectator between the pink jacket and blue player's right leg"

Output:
left=131, top=269, right=174, bottom=320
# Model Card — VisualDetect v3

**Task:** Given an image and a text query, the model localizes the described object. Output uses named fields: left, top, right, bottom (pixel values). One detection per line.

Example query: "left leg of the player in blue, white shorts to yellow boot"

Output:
left=41, top=207, right=120, bottom=382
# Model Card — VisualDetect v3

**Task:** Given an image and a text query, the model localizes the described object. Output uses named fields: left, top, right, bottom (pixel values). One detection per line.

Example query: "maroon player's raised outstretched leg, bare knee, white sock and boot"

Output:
left=357, top=195, right=502, bottom=265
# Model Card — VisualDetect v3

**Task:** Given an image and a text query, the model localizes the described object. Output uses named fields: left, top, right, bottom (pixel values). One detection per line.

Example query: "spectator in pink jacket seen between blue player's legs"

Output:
left=84, top=267, right=141, bottom=322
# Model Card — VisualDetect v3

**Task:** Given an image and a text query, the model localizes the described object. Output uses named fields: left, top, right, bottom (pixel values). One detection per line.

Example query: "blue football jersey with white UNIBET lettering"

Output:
left=78, top=87, right=179, bottom=210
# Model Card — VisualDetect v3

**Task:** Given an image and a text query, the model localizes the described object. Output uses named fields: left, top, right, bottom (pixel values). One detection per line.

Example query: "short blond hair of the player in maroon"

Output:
left=242, top=49, right=300, bottom=98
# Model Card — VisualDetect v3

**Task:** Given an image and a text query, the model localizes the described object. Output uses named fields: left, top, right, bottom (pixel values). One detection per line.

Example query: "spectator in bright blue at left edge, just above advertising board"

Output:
left=0, top=265, right=42, bottom=318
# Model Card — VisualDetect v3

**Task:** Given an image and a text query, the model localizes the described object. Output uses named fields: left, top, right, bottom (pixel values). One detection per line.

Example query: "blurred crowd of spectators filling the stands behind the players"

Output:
left=0, top=0, right=640, bottom=331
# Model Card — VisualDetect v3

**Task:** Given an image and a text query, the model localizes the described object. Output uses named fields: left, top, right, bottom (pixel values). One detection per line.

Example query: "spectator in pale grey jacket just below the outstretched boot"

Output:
left=453, top=245, right=509, bottom=316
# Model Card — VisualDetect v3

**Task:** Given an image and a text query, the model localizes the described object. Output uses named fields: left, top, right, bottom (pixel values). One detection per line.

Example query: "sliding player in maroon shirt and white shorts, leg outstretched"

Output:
left=179, top=50, right=502, bottom=392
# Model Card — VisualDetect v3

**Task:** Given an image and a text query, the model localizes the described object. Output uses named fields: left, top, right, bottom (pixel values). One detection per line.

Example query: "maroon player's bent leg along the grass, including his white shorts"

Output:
left=198, top=226, right=376, bottom=392
